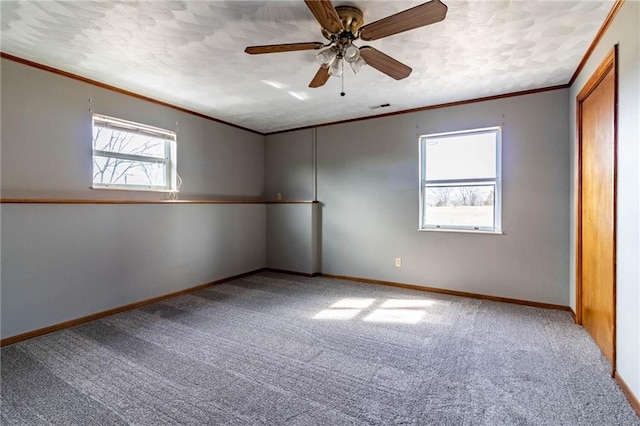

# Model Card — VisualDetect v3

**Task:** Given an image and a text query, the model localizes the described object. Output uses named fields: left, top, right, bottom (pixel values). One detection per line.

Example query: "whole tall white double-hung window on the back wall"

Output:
left=420, top=127, right=501, bottom=233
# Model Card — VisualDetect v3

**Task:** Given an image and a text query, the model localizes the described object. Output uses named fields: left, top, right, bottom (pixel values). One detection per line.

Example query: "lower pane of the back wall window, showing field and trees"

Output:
left=424, top=185, right=495, bottom=228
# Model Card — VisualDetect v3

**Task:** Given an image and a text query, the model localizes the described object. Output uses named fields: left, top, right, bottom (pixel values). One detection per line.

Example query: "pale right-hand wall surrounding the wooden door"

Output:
left=569, top=1, right=640, bottom=399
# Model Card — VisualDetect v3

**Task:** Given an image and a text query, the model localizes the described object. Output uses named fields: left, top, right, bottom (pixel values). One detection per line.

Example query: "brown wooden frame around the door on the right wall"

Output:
left=575, top=44, right=618, bottom=376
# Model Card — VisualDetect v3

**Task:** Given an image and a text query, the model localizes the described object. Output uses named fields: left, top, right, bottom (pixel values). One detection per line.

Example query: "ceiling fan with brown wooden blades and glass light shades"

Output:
left=244, top=0, right=447, bottom=90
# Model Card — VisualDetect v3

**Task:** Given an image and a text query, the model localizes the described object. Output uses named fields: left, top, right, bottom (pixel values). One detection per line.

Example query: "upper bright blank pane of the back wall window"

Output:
left=425, top=131, right=496, bottom=180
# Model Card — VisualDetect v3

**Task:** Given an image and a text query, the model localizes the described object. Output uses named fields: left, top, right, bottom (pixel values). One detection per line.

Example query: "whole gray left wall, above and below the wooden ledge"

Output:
left=0, top=60, right=266, bottom=338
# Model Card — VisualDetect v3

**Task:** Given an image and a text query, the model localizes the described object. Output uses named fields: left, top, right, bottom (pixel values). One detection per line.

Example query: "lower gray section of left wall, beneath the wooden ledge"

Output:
left=1, top=204, right=265, bottom=338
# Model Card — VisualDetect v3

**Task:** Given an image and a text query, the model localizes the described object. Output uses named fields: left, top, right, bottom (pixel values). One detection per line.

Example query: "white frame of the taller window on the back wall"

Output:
left=418, top=126, right=502, bottom=234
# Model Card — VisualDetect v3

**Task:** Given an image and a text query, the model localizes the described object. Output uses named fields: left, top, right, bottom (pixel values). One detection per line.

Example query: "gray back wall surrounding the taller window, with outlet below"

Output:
left=266, top=89, right=570, bottom=305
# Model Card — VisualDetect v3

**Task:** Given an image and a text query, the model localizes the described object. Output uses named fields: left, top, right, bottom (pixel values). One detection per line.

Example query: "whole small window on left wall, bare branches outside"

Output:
left=93, top=114, right=176, bottom=191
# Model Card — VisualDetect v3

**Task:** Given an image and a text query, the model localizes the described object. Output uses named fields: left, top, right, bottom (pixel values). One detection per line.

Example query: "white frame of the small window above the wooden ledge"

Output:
left=91, top=113, right=178, bottom=192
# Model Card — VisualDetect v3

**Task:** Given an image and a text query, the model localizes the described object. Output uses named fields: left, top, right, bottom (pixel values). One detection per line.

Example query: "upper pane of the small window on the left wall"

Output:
left=93, top=125, right=166, bottom=158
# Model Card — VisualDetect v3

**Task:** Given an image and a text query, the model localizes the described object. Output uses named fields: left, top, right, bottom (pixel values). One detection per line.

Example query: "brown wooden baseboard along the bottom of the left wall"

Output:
left=0, top=268, right=264, bottom=347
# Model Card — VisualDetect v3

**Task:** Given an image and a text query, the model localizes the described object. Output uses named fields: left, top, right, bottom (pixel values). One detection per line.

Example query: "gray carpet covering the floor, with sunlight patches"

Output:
left=1, top=272, right=640, bottom=425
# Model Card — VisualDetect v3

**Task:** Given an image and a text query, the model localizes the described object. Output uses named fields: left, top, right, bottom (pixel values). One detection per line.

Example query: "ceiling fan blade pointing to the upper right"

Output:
left=360, top=0, right=447, bottom=41
